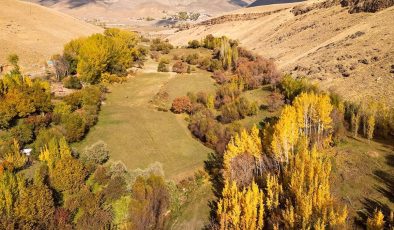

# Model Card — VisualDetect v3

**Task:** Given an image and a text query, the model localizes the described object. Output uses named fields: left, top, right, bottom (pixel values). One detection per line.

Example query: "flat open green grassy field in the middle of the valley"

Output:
left=75, top=61, right=214, bottom=180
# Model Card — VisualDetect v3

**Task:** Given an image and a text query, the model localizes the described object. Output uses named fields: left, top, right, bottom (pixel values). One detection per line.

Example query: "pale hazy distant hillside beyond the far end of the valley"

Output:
left=28, top=0, right=253, bottom=29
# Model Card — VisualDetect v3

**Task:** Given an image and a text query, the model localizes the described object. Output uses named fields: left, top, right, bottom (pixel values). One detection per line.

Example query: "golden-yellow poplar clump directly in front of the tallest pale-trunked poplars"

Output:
left=282, top=141, right=347, bottom=229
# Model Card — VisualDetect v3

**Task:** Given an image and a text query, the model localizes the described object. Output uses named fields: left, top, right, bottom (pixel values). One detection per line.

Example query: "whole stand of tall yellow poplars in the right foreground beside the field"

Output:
left=213, top=93, right=347, bottom=229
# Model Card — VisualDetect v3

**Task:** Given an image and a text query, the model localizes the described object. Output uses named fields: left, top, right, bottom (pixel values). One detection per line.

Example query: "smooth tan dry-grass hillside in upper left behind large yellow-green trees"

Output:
left=0, top=0, right=102, bottom=73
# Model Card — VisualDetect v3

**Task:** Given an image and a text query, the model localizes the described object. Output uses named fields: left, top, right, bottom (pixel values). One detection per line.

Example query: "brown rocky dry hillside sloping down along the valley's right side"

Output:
left=169, top=1, right=394, bottom=105
